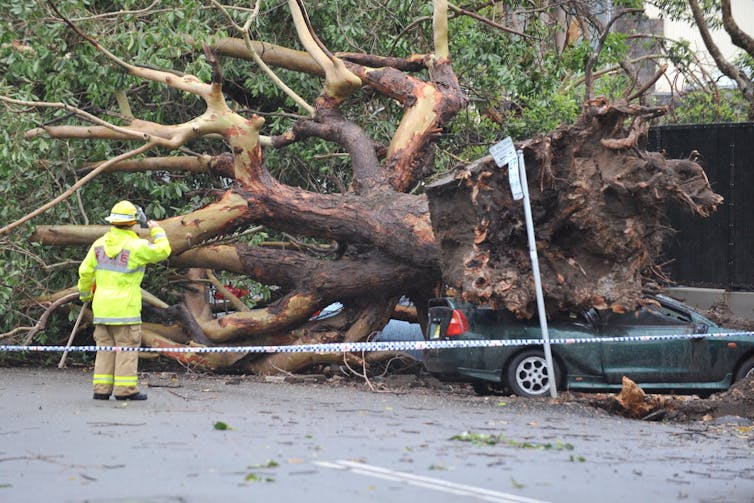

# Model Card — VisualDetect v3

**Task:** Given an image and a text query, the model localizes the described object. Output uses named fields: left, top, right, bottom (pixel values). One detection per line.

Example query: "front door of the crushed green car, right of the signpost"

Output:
left=600, top=306, right=706, bottom=384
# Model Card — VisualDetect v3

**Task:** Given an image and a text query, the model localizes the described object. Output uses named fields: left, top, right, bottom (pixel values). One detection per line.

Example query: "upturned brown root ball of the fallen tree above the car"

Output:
left=427, top=101, right=722, bottom=318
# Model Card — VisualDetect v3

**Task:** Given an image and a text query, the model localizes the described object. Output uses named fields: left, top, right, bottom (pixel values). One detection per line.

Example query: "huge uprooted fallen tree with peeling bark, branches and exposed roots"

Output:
left=0, top=0, right=721, bottom=373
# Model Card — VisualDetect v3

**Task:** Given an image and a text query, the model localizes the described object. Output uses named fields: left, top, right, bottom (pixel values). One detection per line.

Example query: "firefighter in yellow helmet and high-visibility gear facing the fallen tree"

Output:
left=78, top=201, right=171, bottom=400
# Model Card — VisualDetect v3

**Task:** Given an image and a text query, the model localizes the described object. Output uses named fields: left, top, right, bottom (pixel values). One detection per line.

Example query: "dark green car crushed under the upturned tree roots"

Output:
left=424, top=296, right=754, bottom=396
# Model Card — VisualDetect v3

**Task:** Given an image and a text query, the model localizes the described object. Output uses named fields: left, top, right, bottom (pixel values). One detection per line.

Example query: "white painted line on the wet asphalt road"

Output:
left=314, top=460, right=546, bottom=503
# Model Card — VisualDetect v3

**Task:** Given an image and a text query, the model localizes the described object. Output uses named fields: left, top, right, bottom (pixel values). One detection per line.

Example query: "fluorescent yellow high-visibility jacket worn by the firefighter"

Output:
left=78, top=226, right=170, bottom=325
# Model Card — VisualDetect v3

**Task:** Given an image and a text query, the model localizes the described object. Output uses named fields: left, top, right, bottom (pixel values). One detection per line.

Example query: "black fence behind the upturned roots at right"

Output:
left=647, top=122, right=754, bottom=290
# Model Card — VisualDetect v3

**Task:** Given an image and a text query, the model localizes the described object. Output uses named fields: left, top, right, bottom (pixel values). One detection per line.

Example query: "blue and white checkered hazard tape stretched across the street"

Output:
left=0, top=332, right=754, bottom=353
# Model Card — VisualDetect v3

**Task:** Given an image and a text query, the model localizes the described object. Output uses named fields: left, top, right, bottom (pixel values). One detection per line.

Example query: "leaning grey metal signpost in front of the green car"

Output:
left=490, top=137, right=558, bottom=398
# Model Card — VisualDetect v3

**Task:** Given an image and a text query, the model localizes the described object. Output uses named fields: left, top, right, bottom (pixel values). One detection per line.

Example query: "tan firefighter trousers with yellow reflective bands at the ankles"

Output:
left=92, top=325, right=141, bottom=396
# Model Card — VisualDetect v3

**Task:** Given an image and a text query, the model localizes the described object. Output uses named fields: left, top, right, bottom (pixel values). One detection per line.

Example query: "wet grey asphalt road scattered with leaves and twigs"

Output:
left=0, top=368, right=754, bottom=503
